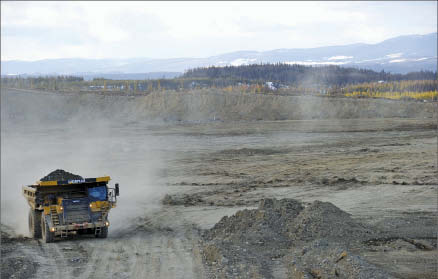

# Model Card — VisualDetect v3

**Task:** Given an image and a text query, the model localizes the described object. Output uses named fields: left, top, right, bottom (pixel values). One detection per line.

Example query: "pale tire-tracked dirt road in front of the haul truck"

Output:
left=0, top=207, right=206, bottom=279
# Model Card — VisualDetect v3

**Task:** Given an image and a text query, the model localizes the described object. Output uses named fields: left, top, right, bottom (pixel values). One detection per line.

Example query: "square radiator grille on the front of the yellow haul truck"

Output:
left=62, top=198, right=91, bottom=224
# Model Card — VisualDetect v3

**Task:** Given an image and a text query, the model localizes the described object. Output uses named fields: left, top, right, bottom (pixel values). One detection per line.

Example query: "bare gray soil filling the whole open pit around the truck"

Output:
left=1, top=90, right=438, bottom=278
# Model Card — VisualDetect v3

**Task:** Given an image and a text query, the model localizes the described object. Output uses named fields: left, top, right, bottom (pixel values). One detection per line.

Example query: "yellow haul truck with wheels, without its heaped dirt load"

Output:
left=23, top=173, right=119, bottom=243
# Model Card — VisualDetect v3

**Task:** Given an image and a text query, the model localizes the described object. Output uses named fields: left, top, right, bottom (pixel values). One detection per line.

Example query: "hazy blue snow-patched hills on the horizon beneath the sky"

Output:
left=1, top=33, right=437, bottom=76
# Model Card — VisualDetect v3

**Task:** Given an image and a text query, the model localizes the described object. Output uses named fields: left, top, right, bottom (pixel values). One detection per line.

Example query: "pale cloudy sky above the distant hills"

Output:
left=1, top=1, right=437, bottom=61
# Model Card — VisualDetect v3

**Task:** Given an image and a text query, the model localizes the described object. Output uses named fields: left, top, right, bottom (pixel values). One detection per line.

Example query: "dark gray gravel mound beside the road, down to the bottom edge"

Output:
left=203, top=199, right=384, bottom=278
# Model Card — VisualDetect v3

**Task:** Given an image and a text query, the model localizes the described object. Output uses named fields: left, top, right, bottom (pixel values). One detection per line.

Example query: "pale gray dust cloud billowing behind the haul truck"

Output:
left=1, top=90, right=171, bottom=236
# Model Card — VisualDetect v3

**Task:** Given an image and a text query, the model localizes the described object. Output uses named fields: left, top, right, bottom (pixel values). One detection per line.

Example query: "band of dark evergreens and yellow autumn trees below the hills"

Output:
left=1, top=63, right=438, bottom=100
